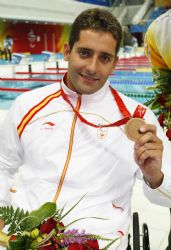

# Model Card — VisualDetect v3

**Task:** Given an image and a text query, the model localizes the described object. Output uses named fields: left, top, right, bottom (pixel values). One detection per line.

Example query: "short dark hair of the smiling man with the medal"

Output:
left=69, top=8, right=122, bottom=54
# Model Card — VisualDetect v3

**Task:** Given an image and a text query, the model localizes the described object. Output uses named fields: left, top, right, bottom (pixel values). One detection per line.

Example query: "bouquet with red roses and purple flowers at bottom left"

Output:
left=0, top=198, right=118, bottom=250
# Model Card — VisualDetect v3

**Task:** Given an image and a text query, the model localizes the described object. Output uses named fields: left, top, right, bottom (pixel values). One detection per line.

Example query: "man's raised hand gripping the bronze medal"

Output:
left=134, top=124, right=163, bottom=189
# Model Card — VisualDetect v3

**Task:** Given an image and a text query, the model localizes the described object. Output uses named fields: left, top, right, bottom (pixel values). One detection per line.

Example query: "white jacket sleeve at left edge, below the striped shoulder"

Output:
left=0, top=99, right=23, bottom=205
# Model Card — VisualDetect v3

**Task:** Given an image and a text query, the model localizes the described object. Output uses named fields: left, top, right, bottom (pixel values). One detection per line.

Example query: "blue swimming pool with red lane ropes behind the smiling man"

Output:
left=0, top=55, right=154, bottom=109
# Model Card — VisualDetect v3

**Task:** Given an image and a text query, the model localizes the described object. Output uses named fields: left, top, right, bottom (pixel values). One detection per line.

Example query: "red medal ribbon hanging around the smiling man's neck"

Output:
left=61, top=86, right=132, bottom=128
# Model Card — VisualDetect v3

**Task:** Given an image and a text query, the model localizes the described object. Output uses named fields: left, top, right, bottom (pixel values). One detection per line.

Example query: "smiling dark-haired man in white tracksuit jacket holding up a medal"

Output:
left=0, top=9, right=171, bottom=250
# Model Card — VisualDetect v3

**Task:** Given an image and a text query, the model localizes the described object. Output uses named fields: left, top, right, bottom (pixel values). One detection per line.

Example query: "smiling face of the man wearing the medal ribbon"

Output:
left=64, top=30, right=117, bottom=94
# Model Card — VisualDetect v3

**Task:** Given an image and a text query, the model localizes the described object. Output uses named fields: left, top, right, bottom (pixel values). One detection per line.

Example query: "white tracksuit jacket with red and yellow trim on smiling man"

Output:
left=0, top=79, right=171, bottom=250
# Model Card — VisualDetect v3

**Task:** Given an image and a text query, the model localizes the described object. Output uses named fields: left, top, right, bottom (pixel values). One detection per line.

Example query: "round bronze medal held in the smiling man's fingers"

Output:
left=125, top=118, right=146, bottom=141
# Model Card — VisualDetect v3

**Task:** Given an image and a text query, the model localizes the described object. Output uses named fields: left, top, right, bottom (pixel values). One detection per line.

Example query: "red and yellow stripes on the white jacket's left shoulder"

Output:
left=17, top=89, right=61, bottom=138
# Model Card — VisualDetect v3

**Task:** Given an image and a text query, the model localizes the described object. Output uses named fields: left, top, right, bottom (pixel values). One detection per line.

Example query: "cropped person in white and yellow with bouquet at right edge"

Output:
left=144, top=10, right=171, bottom=250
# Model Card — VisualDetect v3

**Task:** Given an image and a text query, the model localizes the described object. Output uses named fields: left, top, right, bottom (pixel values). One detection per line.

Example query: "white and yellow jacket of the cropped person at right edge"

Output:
left=144, top=10, right=171, bottom=82
